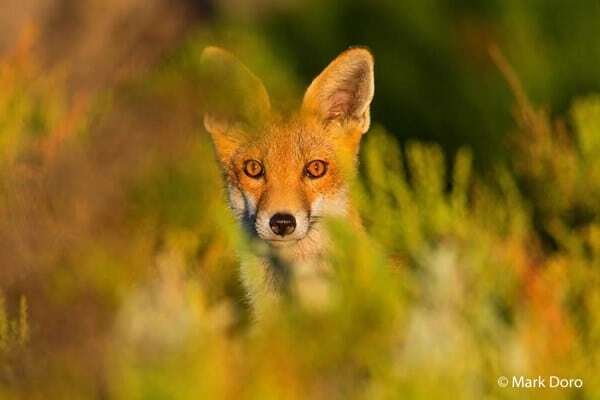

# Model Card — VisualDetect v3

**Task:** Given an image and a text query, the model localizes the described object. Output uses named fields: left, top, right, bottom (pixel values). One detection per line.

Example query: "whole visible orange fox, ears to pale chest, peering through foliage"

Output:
left=201, top=47, right=375, bottom=319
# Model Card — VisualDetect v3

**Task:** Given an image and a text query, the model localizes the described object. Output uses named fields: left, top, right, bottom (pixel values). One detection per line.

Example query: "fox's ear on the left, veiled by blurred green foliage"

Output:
left=201, top=47, right=271, bottom=161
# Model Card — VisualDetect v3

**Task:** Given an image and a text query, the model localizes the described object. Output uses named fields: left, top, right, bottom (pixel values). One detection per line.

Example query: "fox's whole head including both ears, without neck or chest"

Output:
left=202, top=47, right=374, bottom=252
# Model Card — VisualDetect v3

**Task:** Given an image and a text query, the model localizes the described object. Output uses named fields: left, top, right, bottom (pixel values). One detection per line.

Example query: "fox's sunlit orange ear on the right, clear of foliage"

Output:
left=302, top=48, right=375, bottom=133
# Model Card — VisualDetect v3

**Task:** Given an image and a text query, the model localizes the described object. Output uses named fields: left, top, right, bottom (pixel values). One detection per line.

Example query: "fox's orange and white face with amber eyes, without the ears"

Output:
left=218, top=114, right=347, bottom=246
